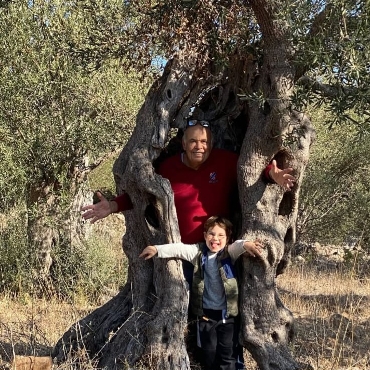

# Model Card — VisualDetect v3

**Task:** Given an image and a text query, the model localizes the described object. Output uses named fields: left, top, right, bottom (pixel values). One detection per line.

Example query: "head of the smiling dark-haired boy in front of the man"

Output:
left=204, top=216, right=233, bottom=252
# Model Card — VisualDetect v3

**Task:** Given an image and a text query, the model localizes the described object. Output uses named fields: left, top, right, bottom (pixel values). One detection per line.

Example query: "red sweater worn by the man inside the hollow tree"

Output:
left=114, top=149, right=269, bottom=244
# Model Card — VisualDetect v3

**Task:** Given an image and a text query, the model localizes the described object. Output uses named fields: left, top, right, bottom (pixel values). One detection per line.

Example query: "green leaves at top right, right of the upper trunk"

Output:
left=286, top=0, right=370, bottom=135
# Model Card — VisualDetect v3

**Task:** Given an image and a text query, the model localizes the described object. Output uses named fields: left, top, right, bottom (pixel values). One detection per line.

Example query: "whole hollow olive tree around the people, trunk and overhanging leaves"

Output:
left=53, top=0, right=368, bottom=370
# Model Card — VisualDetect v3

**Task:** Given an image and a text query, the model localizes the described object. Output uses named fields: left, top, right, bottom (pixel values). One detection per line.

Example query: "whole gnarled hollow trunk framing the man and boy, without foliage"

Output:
left=53, top=1, right=313, bottom=370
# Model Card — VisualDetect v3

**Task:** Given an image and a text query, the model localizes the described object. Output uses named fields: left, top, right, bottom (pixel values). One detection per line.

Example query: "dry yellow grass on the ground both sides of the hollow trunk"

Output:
left=0, top=266, right=370, bottom=370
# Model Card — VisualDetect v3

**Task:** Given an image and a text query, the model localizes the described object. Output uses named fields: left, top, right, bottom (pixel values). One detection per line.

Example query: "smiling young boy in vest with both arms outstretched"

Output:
left=140, top=216, right=263, bottom=370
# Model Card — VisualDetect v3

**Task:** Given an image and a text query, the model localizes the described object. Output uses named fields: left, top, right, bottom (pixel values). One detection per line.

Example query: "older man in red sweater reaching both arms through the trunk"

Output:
left=81, top=120, right=295, bottom=244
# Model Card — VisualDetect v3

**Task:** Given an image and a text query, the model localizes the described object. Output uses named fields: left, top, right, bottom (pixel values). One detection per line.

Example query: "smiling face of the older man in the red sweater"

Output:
left=182, top=125, right=212, bottom=170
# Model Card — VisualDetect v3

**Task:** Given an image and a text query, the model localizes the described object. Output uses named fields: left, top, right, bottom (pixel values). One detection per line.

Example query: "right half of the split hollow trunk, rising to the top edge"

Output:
left=239, top=1, right=314, bottom=370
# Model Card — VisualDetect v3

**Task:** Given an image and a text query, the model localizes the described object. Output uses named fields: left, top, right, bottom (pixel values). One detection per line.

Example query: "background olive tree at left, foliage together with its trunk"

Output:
left=0, top=1, right=145, bottom=290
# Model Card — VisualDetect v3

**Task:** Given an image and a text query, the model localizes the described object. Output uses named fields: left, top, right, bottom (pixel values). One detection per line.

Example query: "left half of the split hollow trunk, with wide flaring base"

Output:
left=53, top=56, right=202, bottom=370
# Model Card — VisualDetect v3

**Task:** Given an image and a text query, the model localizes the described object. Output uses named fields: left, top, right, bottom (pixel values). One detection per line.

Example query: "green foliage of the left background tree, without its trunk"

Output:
left=0, top=1, right=148, bottom=208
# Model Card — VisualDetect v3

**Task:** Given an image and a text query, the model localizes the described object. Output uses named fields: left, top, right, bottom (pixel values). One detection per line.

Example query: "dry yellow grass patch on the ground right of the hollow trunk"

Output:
left=278, top=266, right=370, bottom=370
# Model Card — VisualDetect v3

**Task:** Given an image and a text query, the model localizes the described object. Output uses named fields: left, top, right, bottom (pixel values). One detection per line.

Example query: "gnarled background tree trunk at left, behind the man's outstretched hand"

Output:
left=27, top=176, right=92, bottom=294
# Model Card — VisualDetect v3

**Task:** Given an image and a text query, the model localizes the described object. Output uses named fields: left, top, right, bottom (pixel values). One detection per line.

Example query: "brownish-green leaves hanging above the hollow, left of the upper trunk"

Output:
left=44, top=0, right=256, bottom=74
